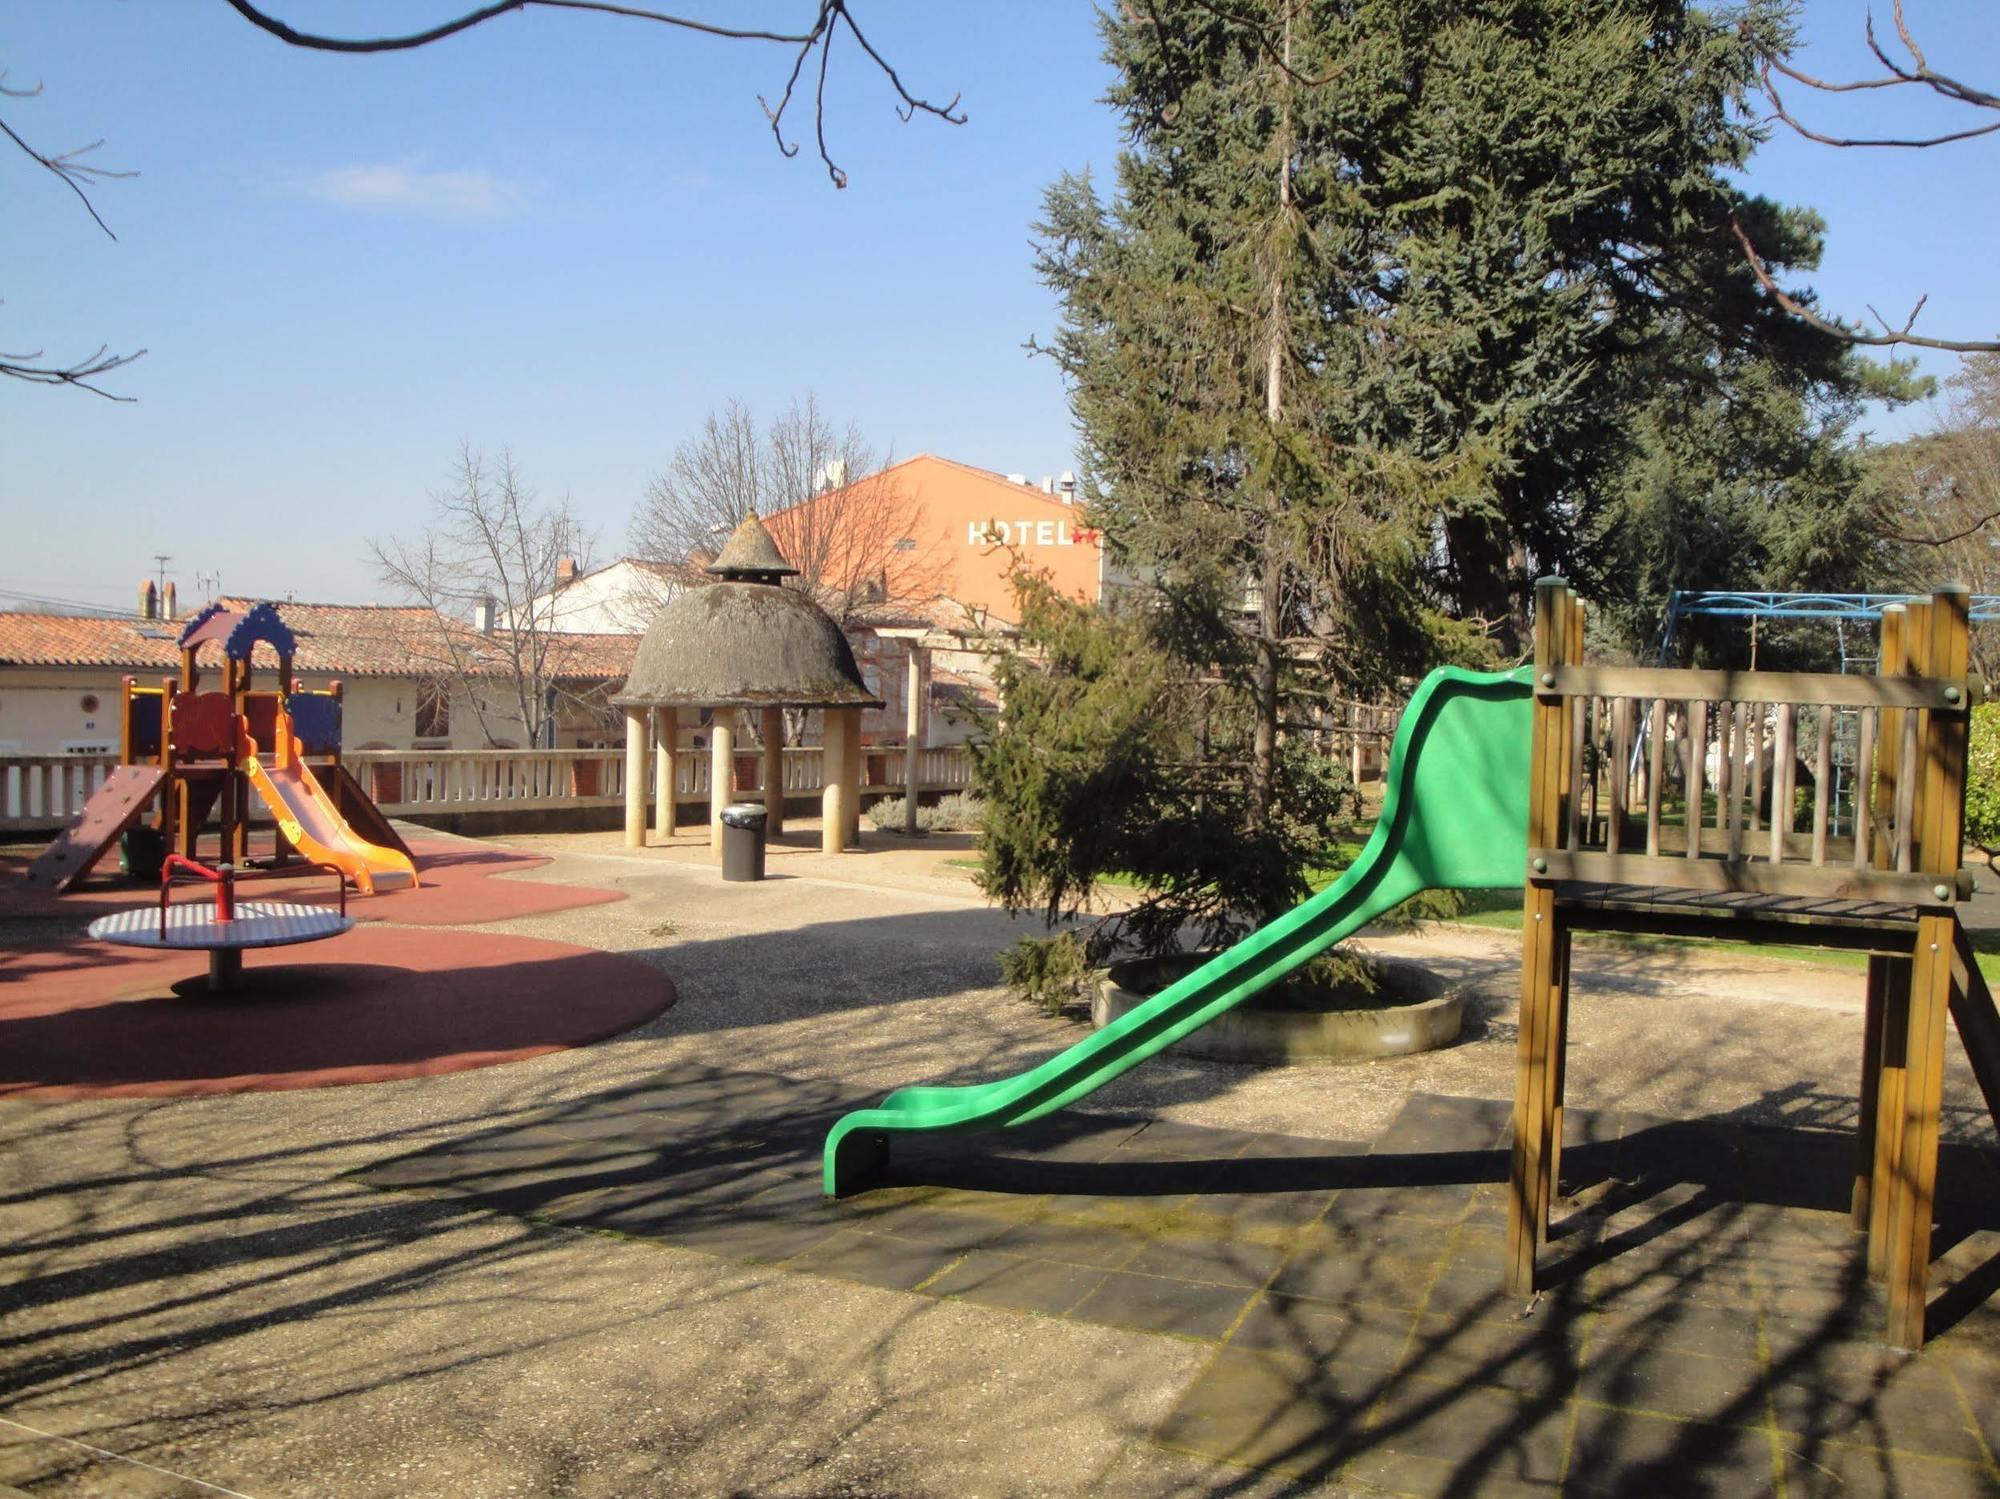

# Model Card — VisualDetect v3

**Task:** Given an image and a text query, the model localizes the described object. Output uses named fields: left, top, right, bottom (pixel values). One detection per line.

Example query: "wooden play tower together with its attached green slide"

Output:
left=822, top=580, right=2000, bottom=1347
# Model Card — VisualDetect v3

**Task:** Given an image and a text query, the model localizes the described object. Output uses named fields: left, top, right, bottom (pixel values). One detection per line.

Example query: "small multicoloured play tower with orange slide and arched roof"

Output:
left=28, top=604, right=416, bottom=895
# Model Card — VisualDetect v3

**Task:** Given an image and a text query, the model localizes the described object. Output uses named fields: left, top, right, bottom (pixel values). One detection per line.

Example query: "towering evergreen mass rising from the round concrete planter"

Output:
left=986, top=0, right=1888, bottom=967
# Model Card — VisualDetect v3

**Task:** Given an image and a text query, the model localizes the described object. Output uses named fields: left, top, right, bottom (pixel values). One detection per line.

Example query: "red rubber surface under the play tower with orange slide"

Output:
left=0, top=839, right=624, bottom=927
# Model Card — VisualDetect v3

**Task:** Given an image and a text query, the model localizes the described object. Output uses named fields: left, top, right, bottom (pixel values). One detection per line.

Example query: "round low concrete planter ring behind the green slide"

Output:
left=1090, top=957, right=1464, bottom=1065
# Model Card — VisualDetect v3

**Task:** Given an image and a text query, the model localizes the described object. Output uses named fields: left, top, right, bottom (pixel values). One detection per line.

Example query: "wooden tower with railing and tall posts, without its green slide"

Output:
left=1506, top=580, right=2000, bottom=1347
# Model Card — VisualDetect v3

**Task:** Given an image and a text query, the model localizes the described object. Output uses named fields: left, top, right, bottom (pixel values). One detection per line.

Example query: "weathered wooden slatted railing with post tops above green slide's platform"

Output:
left=1530, top=590, right=1982, bottom=905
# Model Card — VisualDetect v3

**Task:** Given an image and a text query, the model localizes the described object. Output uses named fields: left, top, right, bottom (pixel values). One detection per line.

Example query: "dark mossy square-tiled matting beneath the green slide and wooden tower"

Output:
left=332, top=1067, right=2000, bottom=1495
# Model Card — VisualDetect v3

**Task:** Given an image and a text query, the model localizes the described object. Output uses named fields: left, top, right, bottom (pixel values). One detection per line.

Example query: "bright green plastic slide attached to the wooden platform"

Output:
left=824, top=666, right=1532, bottom=1197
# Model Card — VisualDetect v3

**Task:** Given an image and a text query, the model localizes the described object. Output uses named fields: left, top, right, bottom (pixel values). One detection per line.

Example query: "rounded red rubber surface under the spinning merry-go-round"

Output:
left=0, top=927, right=674, bottom=1099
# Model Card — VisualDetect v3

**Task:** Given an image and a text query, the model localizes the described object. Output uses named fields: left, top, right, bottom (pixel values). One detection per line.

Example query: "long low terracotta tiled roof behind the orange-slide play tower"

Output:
left=0, top=598, right=638, bottom=682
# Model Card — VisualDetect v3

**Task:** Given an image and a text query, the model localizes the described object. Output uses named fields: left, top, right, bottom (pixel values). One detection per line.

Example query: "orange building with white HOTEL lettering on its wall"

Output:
left=766, top=454, right=1104, bottom=622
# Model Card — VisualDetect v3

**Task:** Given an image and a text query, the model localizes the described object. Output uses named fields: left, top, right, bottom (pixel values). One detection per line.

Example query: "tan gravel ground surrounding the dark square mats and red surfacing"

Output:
left=0, top=833, right=1990, bottom=1499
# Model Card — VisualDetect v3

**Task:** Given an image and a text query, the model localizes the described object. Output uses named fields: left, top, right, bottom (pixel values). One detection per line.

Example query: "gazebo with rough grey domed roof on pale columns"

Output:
left=612, top=514, right=882, bottom=853
